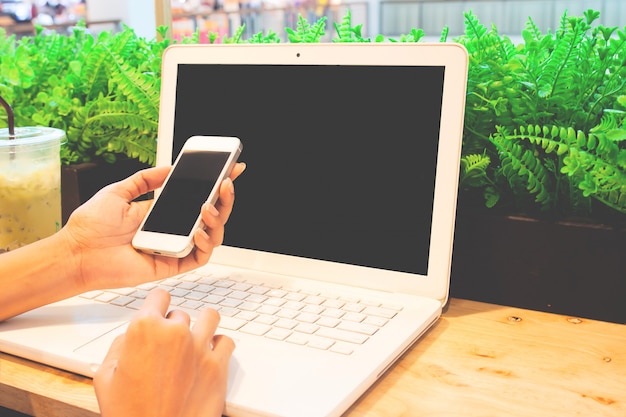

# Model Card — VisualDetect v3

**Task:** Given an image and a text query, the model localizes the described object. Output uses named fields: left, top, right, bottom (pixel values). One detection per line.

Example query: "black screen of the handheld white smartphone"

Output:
left=142, top=150, right=230, bottom=236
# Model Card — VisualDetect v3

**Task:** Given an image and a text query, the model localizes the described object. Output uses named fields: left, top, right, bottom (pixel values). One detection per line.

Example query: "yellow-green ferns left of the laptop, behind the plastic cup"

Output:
left=0, top=24, right=197, bottom=164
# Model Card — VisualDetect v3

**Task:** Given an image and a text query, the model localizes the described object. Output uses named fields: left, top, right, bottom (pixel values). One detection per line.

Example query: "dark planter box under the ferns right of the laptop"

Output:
left=451, top=210, right=626, bottom=323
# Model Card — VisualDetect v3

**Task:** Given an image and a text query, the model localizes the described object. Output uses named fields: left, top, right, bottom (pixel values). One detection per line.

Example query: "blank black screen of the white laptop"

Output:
left=172, top=64, right=444, bottom=275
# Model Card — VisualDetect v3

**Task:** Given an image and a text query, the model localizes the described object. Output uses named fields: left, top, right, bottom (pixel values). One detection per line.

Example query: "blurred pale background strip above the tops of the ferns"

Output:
left=0, top=0, right=626, bottom=41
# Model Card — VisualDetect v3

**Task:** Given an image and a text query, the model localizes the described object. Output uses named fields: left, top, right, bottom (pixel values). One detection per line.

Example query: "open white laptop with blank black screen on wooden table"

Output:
left=0, top=42, right=468, bottom=417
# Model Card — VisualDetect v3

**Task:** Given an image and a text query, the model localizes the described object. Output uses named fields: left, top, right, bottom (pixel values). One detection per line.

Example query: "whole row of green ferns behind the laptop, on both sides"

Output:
left=0, top=9, right=626, bottom=222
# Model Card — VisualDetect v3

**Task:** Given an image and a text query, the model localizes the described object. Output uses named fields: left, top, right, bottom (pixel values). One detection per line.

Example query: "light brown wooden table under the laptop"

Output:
left=0, top=299, right=626, bottom=417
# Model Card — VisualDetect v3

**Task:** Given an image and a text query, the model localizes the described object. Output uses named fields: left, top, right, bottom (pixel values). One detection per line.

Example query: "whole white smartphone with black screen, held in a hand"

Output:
left=132, top=136, right=243, bottom=258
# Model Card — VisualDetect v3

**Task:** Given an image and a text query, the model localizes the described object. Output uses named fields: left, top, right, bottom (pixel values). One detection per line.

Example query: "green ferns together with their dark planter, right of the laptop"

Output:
left=444, top=10, right=626, bottom=322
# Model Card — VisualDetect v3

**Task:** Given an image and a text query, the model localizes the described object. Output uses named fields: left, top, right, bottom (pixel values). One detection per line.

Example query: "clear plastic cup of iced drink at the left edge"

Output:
left=0, top=127, right=65, bottom=253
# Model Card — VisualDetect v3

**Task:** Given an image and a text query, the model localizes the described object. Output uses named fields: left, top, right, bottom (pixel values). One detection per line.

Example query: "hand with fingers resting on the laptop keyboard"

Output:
left=94, top=289, right=230, bottom=417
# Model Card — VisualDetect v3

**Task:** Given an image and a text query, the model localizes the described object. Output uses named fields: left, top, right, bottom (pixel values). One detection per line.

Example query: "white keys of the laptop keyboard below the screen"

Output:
left=81, top=270, right=401, bottom=355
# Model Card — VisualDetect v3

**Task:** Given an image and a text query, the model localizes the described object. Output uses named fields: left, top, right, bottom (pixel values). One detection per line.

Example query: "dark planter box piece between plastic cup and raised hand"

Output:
left=61, top=159, right=148, bottom=224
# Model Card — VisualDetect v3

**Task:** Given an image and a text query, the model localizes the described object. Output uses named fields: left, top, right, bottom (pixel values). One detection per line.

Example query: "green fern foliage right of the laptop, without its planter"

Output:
left=456, top=10, right=626, bottom=220
